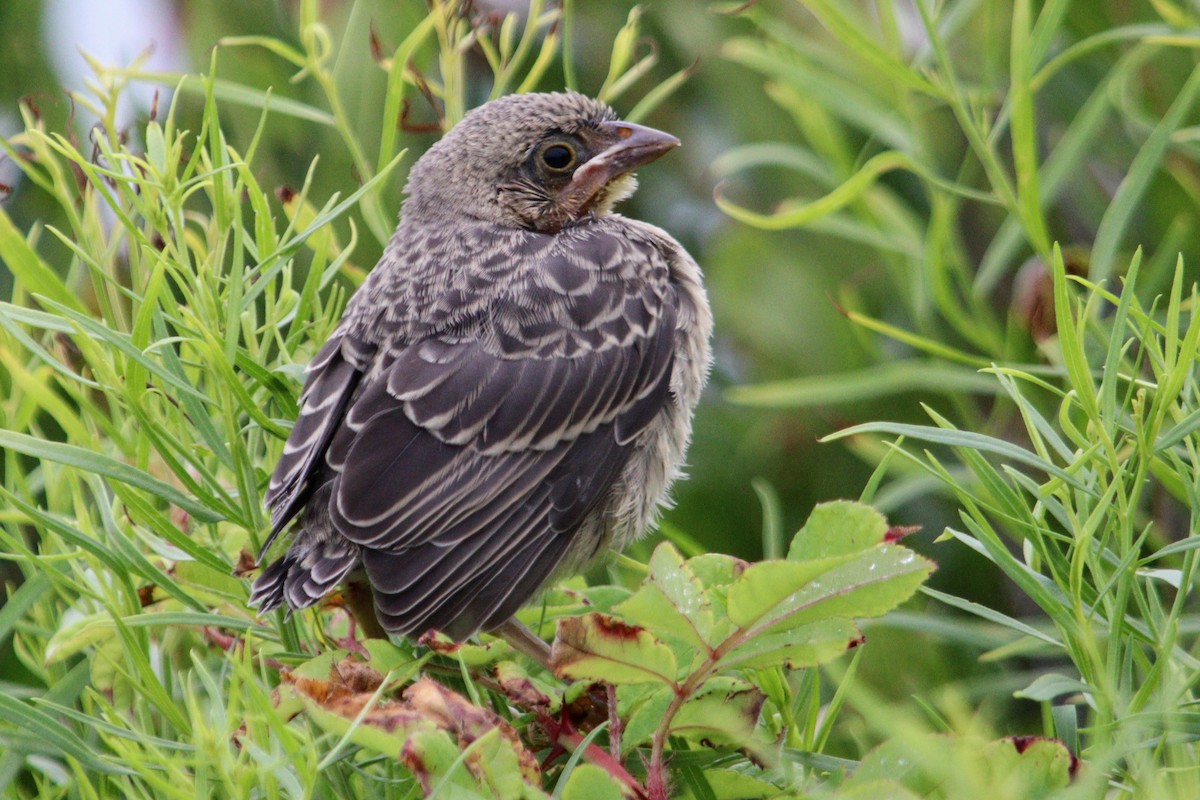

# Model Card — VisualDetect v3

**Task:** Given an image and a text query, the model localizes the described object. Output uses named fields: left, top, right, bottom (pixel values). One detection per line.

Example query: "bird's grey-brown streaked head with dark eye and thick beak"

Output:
left=404, top=92, right=679, bottom=233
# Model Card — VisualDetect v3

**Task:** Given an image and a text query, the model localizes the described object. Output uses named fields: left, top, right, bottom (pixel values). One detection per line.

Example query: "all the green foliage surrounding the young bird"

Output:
left=0, top=0, right=1200, bottom=800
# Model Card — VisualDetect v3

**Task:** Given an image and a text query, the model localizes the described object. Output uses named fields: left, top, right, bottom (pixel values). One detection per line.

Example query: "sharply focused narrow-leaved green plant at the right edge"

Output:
left=838, top=252, right=1200, bottom=796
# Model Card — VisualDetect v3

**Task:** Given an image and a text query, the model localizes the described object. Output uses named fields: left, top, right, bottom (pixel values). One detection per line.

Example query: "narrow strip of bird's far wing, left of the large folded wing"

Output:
left=262, top=332, right=374, bottom=554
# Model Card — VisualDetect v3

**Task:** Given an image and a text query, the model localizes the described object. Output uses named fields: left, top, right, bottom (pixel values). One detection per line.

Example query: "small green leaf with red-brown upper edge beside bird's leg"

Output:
left=550, top=613, right=678, bottom=685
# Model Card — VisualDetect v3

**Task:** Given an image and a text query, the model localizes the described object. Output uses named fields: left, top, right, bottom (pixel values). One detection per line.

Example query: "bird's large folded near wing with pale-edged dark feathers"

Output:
left=326, top=232, right=676, bottom=637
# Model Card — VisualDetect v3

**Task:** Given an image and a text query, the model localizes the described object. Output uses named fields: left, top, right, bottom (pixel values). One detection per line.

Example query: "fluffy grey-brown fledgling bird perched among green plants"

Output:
left=248, top=91, right=713, bottom=645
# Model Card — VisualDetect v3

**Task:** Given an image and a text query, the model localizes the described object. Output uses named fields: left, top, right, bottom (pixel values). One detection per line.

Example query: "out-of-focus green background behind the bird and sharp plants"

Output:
left=0, top=0, right=1200, bottom=767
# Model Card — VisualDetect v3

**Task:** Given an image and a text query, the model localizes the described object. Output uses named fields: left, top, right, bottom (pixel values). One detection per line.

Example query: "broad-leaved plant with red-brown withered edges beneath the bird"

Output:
left=270, top=501, right=934, bottom=798
